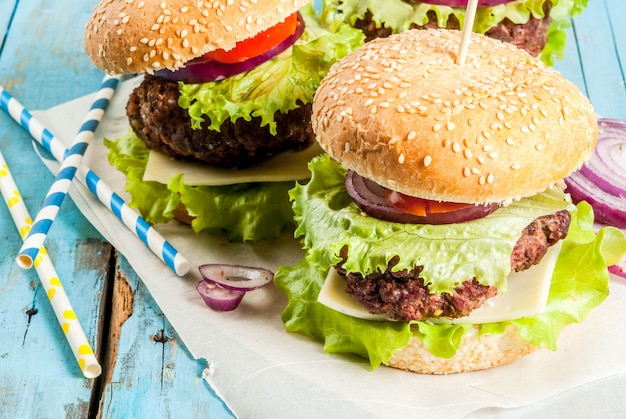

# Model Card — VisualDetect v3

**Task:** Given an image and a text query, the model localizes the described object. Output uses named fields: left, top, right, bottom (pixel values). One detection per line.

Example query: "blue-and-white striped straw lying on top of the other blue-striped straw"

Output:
left=17, top=75, right=119, bottom=268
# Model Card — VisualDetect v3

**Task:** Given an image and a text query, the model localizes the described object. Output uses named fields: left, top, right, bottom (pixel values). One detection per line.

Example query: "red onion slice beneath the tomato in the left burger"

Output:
left=154, top=13, right=304, bottom=84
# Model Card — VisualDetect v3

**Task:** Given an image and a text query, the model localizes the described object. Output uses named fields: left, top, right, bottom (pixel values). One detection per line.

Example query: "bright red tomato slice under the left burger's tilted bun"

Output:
left=204, top=12, right=300, bottom=64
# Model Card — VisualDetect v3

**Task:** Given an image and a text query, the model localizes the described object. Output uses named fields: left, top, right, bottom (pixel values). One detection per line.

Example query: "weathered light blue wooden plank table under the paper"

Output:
left=0, top=0, right=626, bottom=418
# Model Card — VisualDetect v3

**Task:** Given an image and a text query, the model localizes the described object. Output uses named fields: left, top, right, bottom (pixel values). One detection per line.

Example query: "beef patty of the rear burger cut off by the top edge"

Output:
left=354, top=1, right=552, bottom=56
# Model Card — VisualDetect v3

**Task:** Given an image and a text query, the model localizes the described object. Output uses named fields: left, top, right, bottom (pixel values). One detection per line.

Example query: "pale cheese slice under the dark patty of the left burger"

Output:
left=143, top=143, right=323, bottom=186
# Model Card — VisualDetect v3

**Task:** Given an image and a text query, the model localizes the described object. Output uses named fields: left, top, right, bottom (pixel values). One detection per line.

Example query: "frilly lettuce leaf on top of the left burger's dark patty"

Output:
left=178, top=4, right=364, bottom=135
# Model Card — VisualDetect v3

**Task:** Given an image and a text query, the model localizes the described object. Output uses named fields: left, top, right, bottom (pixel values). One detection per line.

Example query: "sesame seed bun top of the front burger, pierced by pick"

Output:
left=313, top=30, right=598, bottom=203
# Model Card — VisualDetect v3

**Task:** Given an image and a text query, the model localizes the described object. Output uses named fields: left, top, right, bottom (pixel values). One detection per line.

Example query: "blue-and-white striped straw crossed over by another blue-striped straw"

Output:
left=0, top=86, right=191, bottom=276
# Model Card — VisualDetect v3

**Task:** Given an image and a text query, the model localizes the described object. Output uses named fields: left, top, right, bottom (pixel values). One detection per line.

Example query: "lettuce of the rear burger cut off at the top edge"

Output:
left=337, top=0, right=588, bottom=65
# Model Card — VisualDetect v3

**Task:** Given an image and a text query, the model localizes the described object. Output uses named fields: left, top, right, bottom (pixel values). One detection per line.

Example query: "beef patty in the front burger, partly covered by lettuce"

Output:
left=337, top=210, right=571, bottom=321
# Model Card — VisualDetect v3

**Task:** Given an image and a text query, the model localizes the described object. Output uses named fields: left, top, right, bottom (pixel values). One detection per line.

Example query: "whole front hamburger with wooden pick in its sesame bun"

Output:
left=274, top=29, right=626, bottom=374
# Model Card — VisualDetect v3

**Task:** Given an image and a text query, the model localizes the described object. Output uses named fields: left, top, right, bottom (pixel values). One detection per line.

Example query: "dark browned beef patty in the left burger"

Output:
left=126, top=75, right=315, bottom=168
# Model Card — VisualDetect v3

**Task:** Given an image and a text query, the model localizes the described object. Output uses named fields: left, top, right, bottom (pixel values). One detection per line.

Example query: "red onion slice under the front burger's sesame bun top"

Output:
left=345, top=170, right=498, bottom=224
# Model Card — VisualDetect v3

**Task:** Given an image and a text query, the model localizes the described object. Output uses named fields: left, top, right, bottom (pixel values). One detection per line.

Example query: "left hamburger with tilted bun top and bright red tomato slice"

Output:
left=84, top=0, right=363, bottom=241
